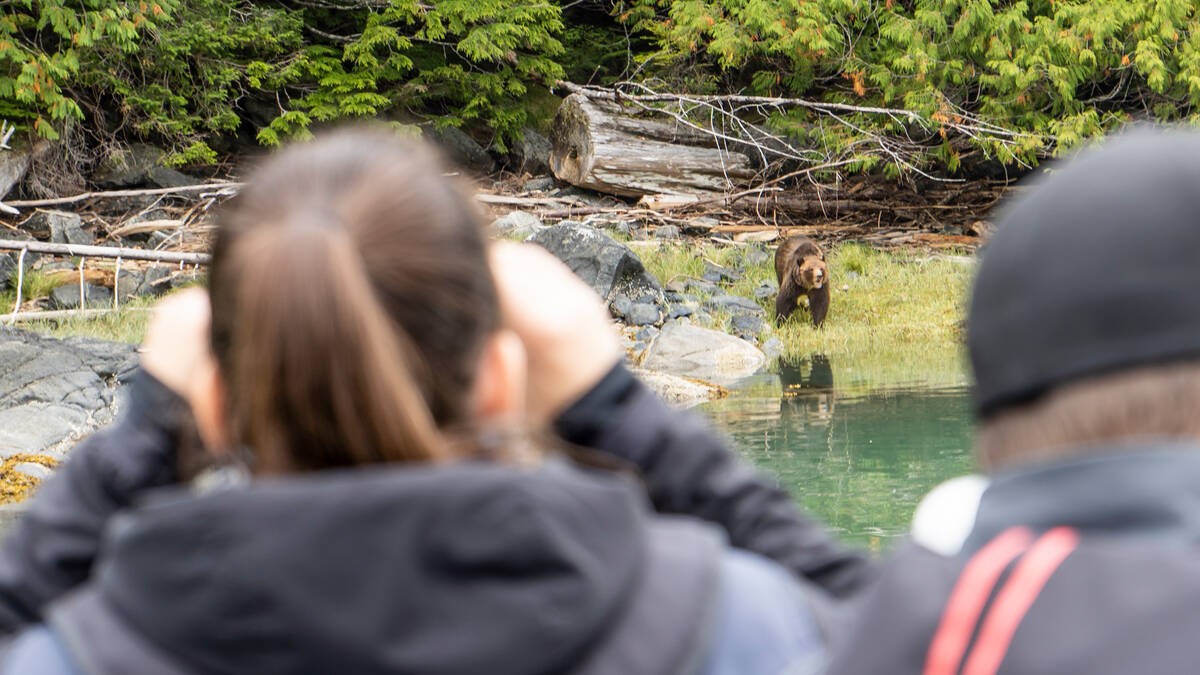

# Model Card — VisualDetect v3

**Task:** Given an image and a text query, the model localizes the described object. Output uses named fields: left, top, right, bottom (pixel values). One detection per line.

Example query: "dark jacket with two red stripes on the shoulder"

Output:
left=830, top=443, right=1200, bottom=675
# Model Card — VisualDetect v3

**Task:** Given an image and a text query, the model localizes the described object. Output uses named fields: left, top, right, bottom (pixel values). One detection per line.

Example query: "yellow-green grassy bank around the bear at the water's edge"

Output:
left=635, top=243, right=973, bottom=386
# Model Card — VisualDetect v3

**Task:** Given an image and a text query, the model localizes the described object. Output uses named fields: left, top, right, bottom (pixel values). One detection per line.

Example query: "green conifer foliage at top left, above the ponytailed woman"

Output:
left=0, top=0, right=563, bottom=163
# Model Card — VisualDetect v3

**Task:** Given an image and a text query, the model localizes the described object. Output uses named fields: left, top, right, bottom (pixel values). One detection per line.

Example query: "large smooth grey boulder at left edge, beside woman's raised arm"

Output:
left=0, top=327, right=138, bottom=456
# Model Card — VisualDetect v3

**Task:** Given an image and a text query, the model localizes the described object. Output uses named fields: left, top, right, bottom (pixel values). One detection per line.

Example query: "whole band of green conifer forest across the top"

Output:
left=0, top=0, right=1200, bottom=189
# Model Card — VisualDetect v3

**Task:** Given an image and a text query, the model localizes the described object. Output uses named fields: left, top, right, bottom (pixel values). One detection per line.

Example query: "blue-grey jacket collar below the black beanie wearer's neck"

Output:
left=964, top=441, right=1200, bottom=552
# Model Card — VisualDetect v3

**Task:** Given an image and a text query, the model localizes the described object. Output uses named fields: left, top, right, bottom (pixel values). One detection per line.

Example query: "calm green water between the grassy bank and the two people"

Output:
left=702, top=356, right=973, bottom=550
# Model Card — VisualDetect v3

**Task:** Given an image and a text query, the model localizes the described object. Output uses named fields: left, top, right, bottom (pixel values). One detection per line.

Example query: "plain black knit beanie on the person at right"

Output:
left=967, top=130, right=1200, bottom=418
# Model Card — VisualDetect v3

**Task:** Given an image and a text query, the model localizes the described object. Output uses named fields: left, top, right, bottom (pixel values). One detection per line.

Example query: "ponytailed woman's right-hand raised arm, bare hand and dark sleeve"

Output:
left=492, top=240, right=871, bottom=596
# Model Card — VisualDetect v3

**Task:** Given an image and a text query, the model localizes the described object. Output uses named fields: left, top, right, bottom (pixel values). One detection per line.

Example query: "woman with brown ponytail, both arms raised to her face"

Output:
left=0, top=129, right=871, bottom=675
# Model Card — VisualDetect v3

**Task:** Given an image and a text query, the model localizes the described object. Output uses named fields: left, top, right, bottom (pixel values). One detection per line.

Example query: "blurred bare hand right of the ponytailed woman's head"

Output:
left=491, top=241, right=622, bottom=425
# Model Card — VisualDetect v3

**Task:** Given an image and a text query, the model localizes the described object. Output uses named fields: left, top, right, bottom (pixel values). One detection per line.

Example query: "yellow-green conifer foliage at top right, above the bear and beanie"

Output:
left=620, top=0, right=1200, bottom=171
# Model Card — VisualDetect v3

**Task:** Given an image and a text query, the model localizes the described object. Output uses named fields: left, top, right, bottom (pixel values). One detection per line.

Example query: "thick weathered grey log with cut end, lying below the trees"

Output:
left=550, top=94, right=755, bottom=197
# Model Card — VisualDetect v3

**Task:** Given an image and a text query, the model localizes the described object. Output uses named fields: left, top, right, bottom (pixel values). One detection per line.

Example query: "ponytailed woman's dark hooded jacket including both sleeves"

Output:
left=0, top=368, right=869, bottom=675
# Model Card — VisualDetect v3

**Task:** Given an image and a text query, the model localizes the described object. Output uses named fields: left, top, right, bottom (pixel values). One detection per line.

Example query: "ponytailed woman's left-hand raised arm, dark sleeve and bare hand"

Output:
left=0, top=289, right=216, bottom=637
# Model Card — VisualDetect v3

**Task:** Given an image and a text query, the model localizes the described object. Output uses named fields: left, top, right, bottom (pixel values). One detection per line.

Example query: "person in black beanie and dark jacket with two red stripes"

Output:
left=832, top=131, right=1200, bottom=675
